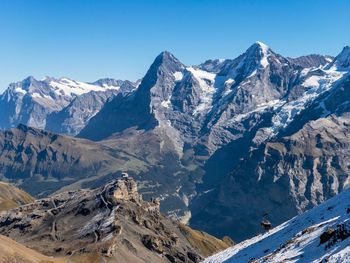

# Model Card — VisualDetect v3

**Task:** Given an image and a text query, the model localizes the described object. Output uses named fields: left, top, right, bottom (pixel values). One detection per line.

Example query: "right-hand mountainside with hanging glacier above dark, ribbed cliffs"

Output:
left=191, top=49, right=350, bottom=241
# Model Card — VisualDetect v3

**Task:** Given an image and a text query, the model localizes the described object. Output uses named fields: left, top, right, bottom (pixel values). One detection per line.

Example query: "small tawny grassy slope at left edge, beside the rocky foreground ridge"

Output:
left=0, top=182, right=34, bottom=212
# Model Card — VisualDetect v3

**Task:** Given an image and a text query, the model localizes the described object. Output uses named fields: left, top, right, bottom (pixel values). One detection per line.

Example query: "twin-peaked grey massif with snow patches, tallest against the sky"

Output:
left=81, top=42, right=340, bottom=154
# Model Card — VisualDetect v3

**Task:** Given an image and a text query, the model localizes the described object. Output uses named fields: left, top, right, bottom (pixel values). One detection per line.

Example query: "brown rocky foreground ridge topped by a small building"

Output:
left=0, top=178, right=228, bottom=262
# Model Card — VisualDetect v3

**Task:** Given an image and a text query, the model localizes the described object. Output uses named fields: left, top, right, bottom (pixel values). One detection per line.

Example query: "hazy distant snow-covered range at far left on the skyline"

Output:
left=0, top=77, right=134, bottom=135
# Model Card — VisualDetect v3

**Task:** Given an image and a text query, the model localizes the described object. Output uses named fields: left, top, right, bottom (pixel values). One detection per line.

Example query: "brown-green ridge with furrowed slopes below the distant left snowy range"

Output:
left=0, top=125, right=147, bottom=196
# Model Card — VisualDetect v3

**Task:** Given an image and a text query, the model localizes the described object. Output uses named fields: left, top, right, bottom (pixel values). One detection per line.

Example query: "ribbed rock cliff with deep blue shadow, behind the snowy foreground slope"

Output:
left=193, top=115, right=350, bottom=240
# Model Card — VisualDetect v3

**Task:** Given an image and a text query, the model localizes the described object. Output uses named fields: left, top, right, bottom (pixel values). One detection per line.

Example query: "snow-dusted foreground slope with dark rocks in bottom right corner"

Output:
left=204, top=190, right=350, bottom=263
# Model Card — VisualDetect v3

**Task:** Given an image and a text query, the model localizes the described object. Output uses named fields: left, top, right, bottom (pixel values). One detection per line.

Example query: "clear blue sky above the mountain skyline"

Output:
left=0, top=0, right=350, bottom=90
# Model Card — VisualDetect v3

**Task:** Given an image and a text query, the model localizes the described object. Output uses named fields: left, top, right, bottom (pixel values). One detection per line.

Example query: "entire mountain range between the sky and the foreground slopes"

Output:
left=0, top=42, right=350, bottom=241
